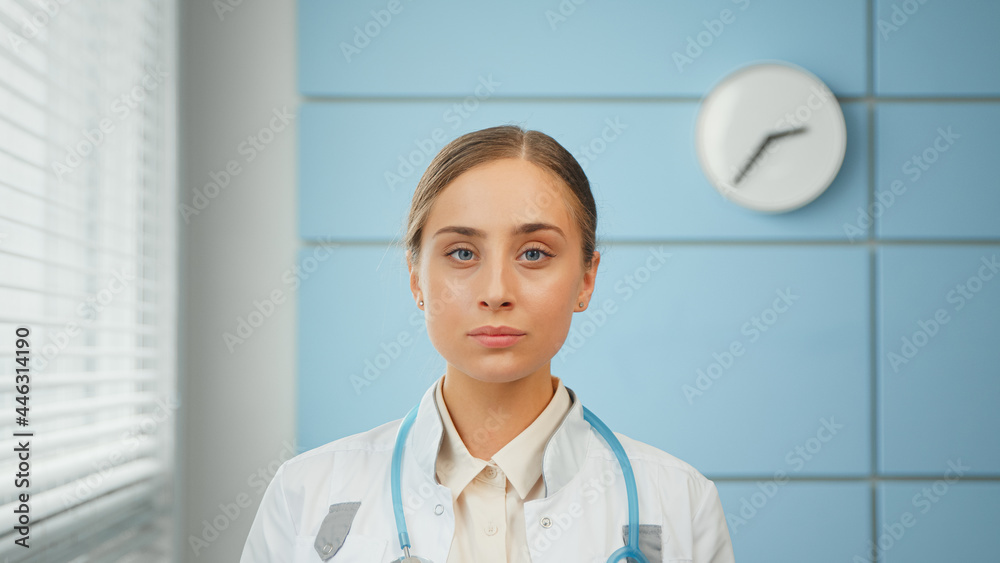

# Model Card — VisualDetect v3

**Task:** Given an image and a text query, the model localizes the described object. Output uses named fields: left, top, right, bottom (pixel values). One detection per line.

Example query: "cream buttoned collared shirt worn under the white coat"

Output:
left=435, top=376, right=572, bottom=563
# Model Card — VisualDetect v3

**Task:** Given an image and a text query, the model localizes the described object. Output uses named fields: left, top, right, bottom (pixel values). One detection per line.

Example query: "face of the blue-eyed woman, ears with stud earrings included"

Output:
left=407, top=158, right=600, bottom=388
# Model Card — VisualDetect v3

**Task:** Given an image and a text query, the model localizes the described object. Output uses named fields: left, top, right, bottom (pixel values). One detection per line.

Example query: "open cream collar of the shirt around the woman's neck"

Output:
left=434, top=377, right=573, bottom=499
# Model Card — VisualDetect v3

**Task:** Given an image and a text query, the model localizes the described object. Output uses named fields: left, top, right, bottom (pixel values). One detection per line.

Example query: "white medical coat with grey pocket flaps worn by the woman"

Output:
left=240, top=386, right=733, bottom=563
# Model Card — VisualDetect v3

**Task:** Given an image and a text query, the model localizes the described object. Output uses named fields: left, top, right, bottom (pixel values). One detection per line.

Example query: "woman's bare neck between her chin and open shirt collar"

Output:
left=441, top=364, right=554, bottom=460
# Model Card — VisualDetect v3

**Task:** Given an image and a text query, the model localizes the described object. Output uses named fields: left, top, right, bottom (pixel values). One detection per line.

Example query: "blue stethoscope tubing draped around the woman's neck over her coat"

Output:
left=390, top=405, right=649, bottom=563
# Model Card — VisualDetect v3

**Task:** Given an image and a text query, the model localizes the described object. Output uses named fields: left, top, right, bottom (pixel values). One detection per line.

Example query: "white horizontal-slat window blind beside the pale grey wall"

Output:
left=0, top=0, right=178, bottom=562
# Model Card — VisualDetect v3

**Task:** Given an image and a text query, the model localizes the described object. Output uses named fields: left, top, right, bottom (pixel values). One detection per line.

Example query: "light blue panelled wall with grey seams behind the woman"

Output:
left=298, top=0, right=1000, bottom=563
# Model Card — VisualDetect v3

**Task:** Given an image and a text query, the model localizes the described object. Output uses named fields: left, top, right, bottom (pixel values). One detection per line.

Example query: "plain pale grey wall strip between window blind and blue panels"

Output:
left=176, top=0, right=298, bottom=563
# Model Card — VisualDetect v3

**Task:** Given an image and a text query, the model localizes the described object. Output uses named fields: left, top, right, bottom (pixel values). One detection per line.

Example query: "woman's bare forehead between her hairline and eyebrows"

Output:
left=427, top=158, right=573, bottom=229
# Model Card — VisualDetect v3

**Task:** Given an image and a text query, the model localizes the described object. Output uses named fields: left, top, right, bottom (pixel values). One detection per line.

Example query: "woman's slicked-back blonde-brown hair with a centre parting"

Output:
left=404, top=125, right=597, bottom=271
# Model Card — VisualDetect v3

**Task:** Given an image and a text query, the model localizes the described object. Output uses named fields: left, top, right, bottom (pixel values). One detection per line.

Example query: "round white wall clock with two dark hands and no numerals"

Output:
left=695, top=63, right=847, bottom=212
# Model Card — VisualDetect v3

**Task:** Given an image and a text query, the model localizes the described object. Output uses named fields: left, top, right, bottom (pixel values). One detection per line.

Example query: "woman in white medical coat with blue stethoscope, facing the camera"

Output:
left=242, top=126, right=733, bottom=563
